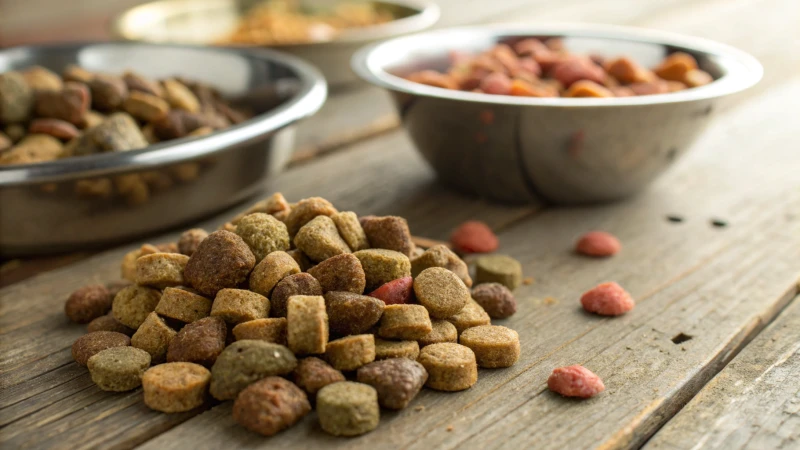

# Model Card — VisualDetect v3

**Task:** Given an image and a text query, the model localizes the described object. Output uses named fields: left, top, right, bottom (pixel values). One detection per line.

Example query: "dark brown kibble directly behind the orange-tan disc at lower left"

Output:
left=167, top=317, right=228, bottom=367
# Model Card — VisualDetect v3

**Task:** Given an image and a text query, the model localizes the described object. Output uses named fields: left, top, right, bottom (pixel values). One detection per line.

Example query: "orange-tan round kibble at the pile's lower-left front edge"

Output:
left=142, top=362, right=211, bottom=413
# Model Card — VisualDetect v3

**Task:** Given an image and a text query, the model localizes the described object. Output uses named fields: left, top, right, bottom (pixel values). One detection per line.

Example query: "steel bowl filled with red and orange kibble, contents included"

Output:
left=352, top=24, right=763, bottom=204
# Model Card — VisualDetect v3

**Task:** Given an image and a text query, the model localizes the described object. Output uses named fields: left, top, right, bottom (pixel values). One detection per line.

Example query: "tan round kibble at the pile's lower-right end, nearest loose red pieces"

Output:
left=458, top=325, right=520, bottom=369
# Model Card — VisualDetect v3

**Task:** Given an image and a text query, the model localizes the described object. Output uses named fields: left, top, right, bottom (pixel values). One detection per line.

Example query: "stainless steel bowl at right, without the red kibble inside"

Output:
left=352, top=24, right=763, bottom=204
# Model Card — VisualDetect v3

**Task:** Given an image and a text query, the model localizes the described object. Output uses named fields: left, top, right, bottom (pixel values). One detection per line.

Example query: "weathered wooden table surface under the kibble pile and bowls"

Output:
left=0, top=0, right=800, bottom=450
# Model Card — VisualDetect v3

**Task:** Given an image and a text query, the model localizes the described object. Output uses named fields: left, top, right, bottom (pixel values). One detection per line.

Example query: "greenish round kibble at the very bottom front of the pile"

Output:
left=317, top=381, right=380, bottom=436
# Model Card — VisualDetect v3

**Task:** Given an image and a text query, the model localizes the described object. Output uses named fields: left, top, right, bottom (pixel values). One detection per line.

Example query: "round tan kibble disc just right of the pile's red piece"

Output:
left=414, top=267, right=470, bottom=319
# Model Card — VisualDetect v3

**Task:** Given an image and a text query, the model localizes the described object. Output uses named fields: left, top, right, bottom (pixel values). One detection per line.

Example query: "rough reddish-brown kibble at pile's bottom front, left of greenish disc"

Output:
left=233, top=377, right=311, bottom=436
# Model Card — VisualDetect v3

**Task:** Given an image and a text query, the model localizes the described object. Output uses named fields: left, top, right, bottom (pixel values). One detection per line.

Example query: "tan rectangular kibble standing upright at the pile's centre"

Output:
left=286, top=295, right=328, bottom=354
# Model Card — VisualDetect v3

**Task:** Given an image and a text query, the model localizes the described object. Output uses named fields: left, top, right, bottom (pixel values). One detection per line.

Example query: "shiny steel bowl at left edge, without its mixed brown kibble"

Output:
left=0, top=43, right=326, bottom=256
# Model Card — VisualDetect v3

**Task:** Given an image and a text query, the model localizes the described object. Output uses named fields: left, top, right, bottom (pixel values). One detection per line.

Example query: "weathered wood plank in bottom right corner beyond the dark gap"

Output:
left=644, top=297, right=800, bottom=450
